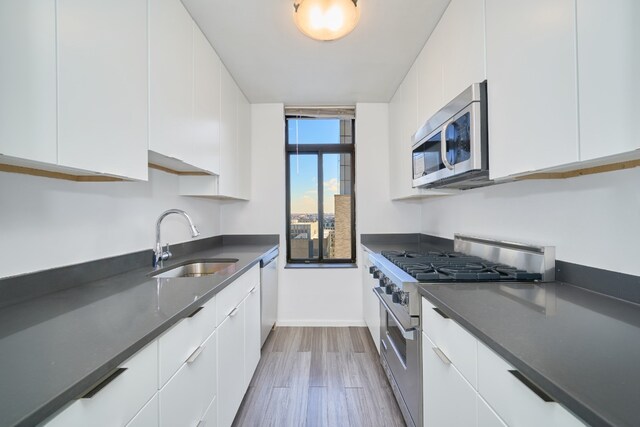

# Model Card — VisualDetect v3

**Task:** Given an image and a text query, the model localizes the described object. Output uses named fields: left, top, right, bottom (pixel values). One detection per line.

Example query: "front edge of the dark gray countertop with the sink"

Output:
left=15, top=243, right=279, bottom=427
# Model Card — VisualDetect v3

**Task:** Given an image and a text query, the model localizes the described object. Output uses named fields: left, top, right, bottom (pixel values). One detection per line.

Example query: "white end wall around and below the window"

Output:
left=221, top=104, right=420, bottom=326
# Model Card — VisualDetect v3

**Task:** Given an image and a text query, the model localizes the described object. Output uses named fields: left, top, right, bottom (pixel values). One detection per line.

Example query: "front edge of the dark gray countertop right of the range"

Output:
left=418, top=286, right=615, bottom=425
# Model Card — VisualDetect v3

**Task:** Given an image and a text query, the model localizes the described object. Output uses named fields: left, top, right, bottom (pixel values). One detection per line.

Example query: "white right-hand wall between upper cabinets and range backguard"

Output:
left=422, top=168, right=640, bottom=275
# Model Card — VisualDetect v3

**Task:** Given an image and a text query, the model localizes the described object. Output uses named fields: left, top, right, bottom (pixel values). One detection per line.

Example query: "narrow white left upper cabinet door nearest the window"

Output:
left=236, top=90, right=252, bottom=200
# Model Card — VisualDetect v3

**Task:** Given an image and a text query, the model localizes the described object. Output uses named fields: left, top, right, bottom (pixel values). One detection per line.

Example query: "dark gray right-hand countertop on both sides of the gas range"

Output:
left=365, top=242, right=640, bottom=426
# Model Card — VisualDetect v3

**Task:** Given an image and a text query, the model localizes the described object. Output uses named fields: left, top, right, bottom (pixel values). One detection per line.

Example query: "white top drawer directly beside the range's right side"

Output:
left=422, top=298, right=478, bottom=389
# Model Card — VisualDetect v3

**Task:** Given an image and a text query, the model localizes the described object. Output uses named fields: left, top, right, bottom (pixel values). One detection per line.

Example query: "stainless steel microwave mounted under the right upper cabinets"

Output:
left=412, top=80, right=492, bottom=190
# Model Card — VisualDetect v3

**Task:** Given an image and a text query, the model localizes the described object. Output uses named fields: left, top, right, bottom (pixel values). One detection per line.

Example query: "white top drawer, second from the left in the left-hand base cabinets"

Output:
left=158, top=296, right=217, bottom=388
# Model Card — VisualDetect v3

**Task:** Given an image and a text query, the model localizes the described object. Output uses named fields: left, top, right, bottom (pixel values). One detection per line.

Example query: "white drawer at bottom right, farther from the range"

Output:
left=478, top=342, right=584, bottom=427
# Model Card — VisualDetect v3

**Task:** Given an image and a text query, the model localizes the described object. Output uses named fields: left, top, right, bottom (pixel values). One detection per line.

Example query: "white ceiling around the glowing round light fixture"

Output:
left=182, top=0, right=450, bottom=105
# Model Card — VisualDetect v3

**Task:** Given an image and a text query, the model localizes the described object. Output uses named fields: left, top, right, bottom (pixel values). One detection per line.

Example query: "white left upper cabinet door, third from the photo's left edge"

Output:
left=149, top=0, right=198, bottom=163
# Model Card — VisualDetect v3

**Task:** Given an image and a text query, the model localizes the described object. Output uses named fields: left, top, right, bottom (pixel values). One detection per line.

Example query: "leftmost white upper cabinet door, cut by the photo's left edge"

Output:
left=0, top=0, right=57, bottom=164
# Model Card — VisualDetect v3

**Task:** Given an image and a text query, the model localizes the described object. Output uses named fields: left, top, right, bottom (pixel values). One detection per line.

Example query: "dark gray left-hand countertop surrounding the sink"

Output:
left=0, top=243, right=277, bottom=426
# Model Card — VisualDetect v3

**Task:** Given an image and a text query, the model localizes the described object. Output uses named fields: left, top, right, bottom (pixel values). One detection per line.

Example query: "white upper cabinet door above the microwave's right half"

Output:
left=440, top=0, right=486, bottom=101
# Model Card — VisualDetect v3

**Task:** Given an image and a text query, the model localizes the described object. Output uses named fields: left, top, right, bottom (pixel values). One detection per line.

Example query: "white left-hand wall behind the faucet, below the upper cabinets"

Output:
left=0, top=169, right=220, bottom=277
